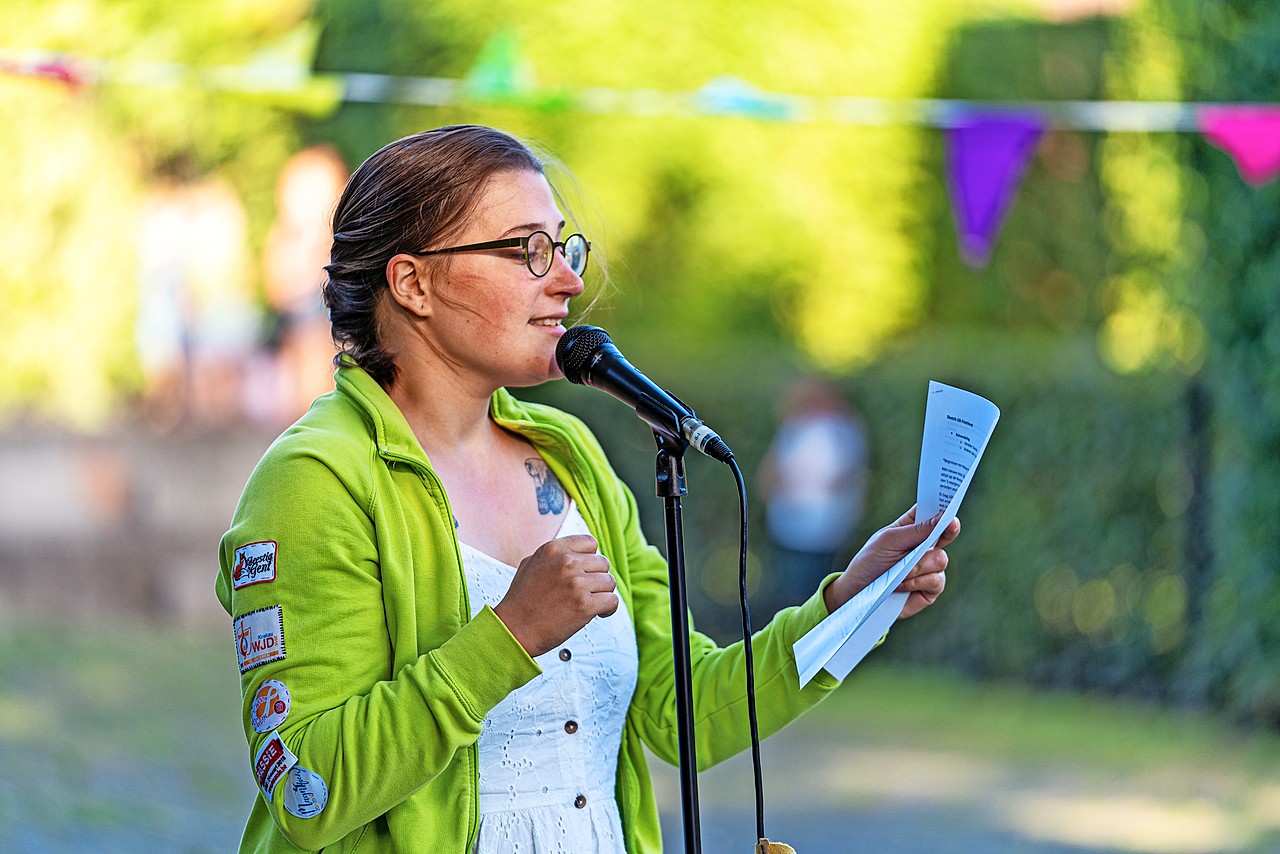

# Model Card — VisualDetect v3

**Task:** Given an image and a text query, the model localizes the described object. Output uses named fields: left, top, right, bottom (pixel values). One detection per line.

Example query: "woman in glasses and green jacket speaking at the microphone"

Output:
left=218, top=127, right=959, bottom=854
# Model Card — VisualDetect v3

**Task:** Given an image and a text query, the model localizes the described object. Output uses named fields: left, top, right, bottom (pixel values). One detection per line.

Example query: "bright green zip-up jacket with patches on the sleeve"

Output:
left=216, top=362, right=837, bottom=854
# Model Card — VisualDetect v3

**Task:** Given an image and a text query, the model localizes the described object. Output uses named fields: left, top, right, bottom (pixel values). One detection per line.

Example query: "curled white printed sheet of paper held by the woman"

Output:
left=794, top=380, right=1000, bottom=686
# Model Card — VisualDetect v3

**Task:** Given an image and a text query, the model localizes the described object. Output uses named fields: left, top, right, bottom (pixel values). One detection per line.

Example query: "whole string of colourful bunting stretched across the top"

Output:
left=0, top=42, right=1280, bottom=268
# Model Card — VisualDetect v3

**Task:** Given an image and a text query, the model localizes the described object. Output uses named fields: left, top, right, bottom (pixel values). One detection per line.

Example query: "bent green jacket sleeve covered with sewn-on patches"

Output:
left=216, top=452, right=540, bottom=850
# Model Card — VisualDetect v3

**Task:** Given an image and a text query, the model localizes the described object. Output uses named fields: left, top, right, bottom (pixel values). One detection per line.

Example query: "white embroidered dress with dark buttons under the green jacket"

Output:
left=462, top=501, right=637, bottom=854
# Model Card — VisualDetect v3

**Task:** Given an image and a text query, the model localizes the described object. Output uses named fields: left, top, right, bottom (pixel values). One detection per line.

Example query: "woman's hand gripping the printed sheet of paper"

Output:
left=823, top=507, right=960, bottom=620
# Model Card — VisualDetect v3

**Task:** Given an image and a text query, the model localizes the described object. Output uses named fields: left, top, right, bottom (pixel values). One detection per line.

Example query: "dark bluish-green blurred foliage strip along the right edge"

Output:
left=1155, top=0, right=1280, bottom=726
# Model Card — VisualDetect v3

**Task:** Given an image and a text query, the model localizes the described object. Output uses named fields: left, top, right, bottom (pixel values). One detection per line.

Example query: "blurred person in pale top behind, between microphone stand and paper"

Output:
left=760, top=376, right=868, bottom=611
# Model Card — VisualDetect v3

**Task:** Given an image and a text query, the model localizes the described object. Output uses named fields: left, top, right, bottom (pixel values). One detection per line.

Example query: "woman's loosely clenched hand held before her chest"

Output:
left=494, top=534, right=618, bottom=657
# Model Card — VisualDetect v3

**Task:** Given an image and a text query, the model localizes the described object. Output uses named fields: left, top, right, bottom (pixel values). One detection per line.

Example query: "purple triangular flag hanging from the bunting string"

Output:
left=946, top=110, right=1047, bottom=268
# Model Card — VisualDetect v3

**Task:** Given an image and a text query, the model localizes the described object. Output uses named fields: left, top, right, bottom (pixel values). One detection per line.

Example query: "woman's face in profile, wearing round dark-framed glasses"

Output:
left=426, top=172, right=582, bottom=388
